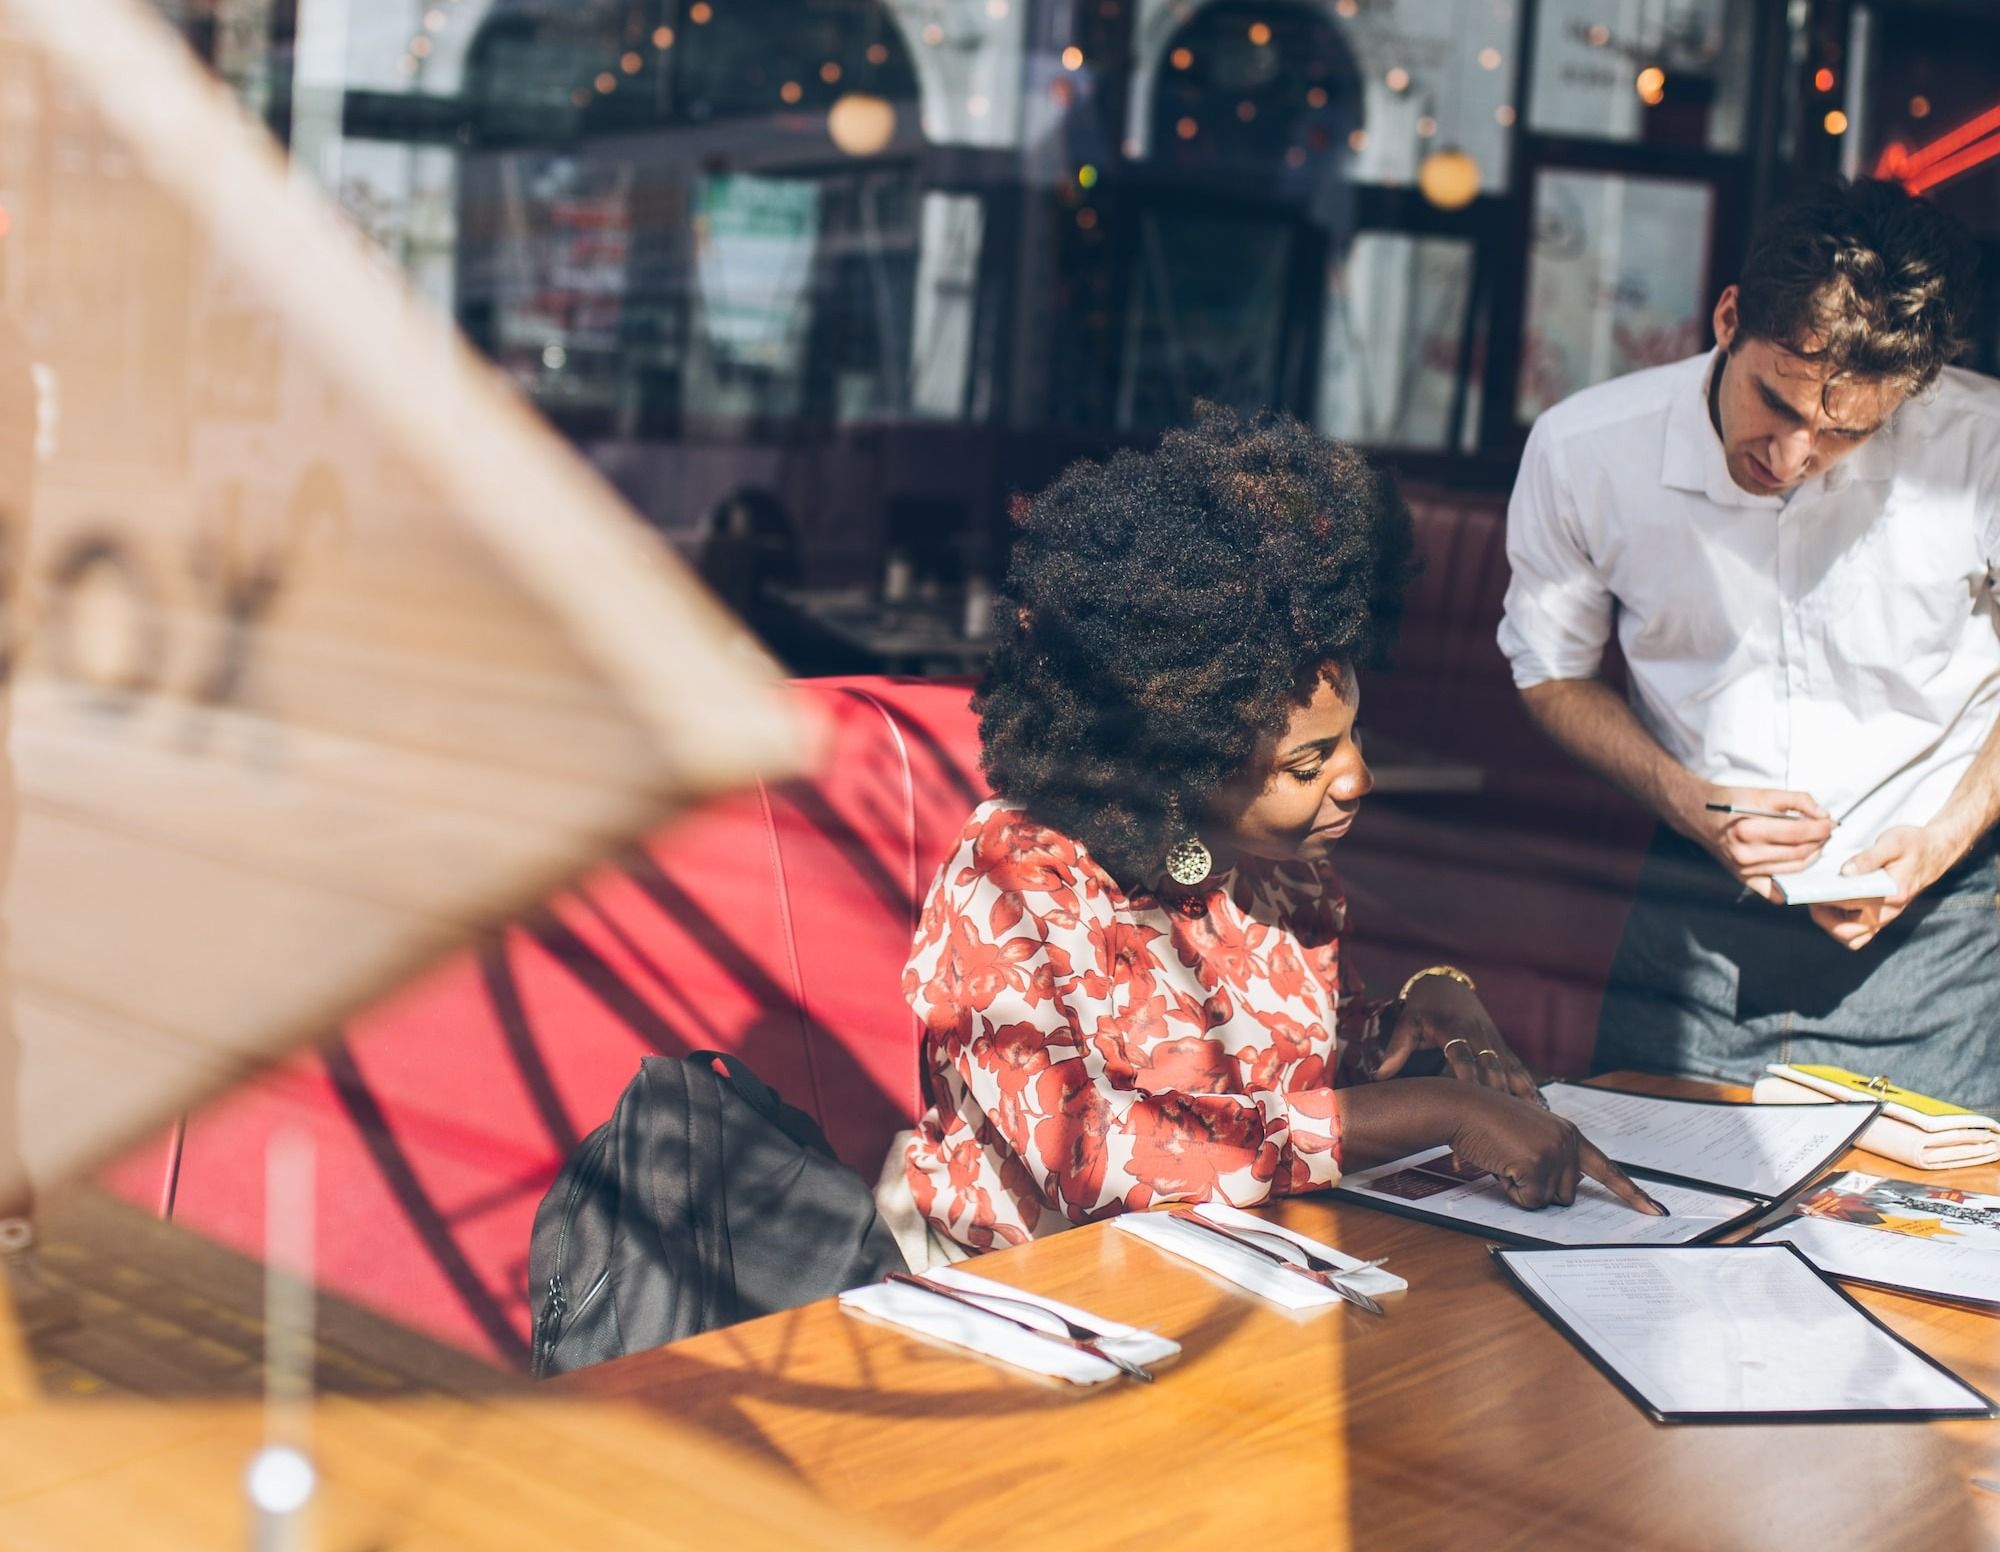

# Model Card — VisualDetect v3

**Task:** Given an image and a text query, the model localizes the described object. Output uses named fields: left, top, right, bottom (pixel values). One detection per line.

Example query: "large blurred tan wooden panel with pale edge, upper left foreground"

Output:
left=0, top=0, right=802, bottom=1216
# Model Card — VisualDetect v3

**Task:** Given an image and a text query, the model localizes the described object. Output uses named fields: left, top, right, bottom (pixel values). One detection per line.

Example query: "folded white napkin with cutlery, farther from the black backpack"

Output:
left=840, top=1266, right=1180, bottom=1384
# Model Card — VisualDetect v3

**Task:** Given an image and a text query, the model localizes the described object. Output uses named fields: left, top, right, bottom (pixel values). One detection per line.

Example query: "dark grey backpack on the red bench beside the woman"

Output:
left=528, top=1050, right=904, bottom=1378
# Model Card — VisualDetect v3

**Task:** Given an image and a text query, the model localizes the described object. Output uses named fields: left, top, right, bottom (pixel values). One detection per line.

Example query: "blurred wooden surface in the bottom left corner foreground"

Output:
left=0, top=1190, right=896, bottom=1552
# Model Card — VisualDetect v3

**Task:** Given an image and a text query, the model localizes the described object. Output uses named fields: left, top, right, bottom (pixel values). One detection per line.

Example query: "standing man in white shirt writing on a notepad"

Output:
left=1500, top=182, right=2000, bottom=1106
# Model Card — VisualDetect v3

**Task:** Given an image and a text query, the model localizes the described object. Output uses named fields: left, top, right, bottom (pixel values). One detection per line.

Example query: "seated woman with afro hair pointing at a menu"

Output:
left=884, top=408, right=1660, bottom=1260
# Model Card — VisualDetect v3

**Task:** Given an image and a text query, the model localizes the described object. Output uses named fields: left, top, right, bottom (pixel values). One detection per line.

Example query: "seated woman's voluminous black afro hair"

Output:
left=974, top=406, right=1416, bottom=888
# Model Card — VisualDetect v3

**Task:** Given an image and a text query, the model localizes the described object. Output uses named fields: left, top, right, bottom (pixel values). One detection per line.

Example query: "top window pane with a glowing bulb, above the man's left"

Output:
left=1528, top=0, right=1756, bottom=150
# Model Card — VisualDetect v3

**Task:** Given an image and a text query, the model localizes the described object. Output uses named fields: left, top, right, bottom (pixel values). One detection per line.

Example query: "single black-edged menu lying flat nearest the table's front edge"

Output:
left=1494, top=1244, right=1994, bottom=1422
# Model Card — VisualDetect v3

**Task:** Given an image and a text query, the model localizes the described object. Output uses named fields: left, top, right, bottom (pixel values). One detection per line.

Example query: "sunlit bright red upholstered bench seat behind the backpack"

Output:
left=108, top=678, right=986, bottom=1364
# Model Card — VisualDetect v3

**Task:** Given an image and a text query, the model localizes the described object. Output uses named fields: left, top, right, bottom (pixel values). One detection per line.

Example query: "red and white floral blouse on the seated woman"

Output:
left=902, top=800, right=1380, bottom=1250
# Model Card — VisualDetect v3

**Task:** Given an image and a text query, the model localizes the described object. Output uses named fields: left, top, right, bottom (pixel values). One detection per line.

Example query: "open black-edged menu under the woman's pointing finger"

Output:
left=1334, top=1084, right=1880, bottom=1246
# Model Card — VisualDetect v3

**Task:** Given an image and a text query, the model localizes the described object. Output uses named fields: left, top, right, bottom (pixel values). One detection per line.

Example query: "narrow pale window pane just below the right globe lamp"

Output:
left=1316, top=232, right=1478, bottom=448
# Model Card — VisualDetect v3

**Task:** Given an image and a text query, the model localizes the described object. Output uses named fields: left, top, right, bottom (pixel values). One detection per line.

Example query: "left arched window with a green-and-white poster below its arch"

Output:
left=458, top=0, right=920, bottom=440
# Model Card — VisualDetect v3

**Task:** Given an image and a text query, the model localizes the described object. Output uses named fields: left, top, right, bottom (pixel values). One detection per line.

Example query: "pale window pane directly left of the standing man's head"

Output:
left=1520, top=172, right=1714, bottom=422
